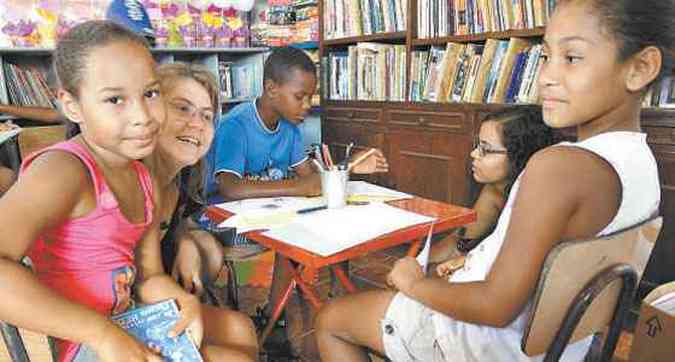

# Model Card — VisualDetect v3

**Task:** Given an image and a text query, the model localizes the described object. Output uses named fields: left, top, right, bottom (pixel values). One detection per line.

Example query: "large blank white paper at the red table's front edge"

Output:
left=263, top=203, right=434, bottom=256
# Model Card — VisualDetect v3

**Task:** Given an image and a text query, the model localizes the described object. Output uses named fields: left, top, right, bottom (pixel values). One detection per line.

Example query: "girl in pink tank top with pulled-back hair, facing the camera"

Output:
left=0, top=21, right=166, bottom=361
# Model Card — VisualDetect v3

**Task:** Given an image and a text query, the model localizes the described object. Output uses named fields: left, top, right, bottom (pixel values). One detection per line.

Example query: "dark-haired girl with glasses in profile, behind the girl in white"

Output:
left=430, top=109, right=558, bottom=276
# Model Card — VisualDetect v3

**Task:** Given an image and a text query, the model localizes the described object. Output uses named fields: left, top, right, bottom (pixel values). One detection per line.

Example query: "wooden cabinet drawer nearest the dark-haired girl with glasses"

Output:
left=387, top=110, right=469, bottom=133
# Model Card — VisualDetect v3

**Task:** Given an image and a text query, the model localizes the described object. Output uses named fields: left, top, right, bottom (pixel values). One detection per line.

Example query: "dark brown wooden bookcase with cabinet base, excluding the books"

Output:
left=319, top=0, right=675, bottom=295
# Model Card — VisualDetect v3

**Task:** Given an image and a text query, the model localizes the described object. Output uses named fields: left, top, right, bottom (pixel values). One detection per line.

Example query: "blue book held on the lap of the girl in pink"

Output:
left=111, top=299, right=203, bottom=362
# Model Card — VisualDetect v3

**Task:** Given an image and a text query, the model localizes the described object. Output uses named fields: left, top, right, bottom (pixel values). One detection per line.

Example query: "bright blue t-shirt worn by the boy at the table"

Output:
left=207, top=102, right=307, bottom=202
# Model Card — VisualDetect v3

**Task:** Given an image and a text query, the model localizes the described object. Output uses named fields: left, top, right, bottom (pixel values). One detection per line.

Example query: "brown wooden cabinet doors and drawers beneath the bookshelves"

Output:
left=322, top=106, right=475, bottom=205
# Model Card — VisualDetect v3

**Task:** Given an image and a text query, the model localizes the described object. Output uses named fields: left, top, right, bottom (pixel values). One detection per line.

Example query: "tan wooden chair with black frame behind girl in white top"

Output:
left=521, top=217, right=662, bottom=361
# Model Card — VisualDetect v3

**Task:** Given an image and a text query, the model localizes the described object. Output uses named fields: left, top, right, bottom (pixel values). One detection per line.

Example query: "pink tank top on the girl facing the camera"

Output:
left=21, top=141, right=153, bottom=361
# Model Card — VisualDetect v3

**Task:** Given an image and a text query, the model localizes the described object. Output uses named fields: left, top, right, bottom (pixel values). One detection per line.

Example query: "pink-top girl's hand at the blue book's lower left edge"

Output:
left=92, top=322, right=163, bottom=362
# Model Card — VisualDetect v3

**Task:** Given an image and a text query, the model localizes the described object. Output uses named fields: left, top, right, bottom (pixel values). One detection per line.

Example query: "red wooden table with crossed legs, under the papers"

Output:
left=207, top=197, right=476, bottom=345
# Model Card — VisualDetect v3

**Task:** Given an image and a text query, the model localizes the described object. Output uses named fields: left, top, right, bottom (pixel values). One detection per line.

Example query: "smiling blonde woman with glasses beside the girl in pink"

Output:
left=143, top=63, right=257, bottom=361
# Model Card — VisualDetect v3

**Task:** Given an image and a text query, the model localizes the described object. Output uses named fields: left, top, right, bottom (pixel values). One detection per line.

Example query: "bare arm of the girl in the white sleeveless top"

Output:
left=389, top=149, right=620, bottom=327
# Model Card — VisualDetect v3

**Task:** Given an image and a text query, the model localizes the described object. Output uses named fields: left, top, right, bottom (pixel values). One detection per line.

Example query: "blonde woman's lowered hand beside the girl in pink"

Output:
left=171, top=237, right=204, bottom=296
